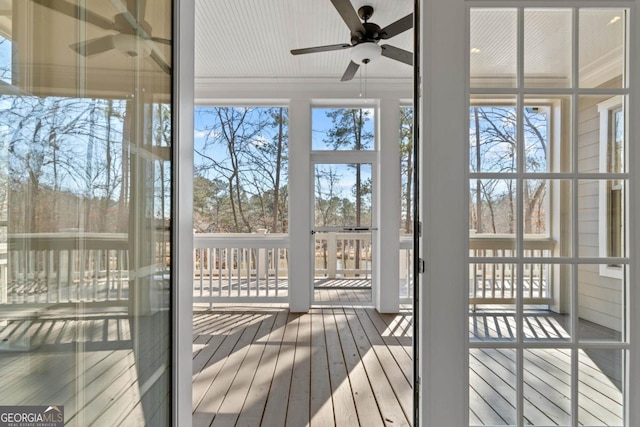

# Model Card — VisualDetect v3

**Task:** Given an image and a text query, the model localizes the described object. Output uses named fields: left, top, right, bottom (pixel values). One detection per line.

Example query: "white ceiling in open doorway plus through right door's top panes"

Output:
left=195, top=0, right=624, bottom=88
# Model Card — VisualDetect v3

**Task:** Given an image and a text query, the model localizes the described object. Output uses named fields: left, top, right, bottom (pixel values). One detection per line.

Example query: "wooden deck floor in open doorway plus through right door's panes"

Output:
left=193, top=306, right=622, bottom=427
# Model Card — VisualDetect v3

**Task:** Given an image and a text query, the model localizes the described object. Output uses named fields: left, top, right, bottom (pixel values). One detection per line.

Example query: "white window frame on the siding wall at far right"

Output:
left=598, top=96, right=626, bottom=279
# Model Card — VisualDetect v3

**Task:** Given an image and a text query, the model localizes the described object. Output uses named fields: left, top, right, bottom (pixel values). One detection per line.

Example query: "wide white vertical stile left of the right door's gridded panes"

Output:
left=418, top=0, right=469, bottom=427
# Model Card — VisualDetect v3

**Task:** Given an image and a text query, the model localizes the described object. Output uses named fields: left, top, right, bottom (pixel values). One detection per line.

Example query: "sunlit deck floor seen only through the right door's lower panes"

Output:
left=469, top=310, right=623, bottom=426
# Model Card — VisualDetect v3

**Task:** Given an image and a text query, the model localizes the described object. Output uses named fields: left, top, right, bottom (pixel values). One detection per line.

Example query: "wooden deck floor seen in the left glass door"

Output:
left=0, top=308, right=170, bottom=426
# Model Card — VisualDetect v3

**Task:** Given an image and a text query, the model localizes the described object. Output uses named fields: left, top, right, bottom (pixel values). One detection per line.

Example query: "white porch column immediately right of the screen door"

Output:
left=373, top=98, right=400, bottom=313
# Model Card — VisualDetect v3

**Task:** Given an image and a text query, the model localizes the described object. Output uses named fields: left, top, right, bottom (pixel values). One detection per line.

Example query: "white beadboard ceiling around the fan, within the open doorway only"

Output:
left=195, top=0, right=413, bottom=81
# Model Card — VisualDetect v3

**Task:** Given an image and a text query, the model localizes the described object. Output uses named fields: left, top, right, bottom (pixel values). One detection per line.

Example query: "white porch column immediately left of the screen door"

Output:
left=289, top=99, right=313, bottom=313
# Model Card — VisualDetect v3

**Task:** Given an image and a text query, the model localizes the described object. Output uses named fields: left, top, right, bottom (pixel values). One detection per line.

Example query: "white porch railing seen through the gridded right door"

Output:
left=469, top=236, right=555, bottom=305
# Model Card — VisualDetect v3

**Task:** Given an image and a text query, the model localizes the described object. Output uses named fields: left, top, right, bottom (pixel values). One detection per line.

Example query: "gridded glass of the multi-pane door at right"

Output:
left=465, top=2, right=637, bottom=427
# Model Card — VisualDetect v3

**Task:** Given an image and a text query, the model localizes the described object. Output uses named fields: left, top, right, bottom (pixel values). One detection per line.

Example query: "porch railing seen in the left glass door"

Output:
left=0, top=232, right=129, bottom=304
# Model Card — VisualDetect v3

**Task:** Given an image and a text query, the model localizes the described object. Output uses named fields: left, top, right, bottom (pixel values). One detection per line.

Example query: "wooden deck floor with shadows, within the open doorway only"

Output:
left=193, top=306, right=412, bottom=427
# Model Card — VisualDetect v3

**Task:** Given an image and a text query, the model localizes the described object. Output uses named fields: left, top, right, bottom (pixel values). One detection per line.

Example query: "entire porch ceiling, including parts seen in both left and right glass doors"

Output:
left=16, top=0, right=624, bottom=96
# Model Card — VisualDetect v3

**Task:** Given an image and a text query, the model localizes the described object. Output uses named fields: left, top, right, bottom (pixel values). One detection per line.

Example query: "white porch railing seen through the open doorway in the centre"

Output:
left=193, top=232, right=413, bottom=303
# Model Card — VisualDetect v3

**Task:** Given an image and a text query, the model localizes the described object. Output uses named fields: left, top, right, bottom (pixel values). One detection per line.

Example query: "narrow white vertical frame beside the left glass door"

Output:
left=172, top=0, right=195, bottom=426
